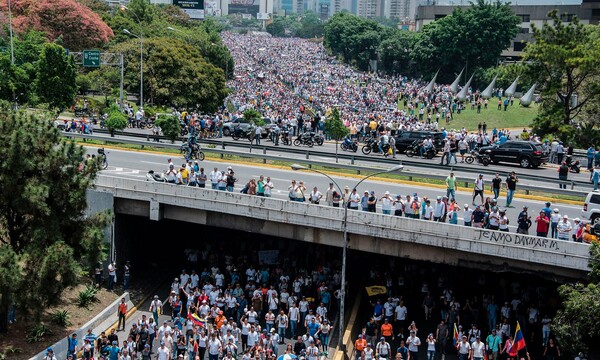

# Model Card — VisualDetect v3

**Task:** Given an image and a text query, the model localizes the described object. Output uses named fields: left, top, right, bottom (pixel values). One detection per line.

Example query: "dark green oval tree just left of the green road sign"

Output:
left=35, top=43, right=77, bottom=110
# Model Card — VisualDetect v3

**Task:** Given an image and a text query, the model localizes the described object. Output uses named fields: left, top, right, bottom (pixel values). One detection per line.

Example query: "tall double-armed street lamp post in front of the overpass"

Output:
left=291, top=164, right=404, bottom=352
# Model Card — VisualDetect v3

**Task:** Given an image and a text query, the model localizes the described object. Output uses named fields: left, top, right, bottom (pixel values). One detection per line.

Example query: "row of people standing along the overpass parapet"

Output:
left=155, top=159, right=595, bottom=243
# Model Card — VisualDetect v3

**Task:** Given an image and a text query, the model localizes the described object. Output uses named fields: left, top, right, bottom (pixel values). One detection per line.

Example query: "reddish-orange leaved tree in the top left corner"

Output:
left=1, top=0, right=114, bottom=51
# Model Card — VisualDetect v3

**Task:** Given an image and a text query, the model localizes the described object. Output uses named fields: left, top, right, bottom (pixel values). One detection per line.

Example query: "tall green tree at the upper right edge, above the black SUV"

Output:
left=525, top=11, right=600, bottom=146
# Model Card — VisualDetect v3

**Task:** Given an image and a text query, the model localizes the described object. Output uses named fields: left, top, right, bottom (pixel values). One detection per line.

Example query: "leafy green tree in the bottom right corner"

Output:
left=552, top=243, right=600, bottom=359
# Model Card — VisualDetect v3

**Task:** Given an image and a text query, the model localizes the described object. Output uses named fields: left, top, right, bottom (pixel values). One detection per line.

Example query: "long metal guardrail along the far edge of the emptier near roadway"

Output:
left=63, top=133, right=589, bottom=197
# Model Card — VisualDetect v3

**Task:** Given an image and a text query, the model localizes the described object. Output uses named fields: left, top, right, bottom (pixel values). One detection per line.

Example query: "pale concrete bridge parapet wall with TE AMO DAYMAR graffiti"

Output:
left=95, top=175, right=589, bottom=272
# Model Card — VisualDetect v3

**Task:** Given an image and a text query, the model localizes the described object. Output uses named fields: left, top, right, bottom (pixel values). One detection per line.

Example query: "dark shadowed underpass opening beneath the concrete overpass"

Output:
left=115, top=214, right=561, bottom=359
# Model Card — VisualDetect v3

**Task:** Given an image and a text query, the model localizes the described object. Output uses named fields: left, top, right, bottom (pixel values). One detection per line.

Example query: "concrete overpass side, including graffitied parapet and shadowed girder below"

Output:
left=88, top=175, right=589, bottom=279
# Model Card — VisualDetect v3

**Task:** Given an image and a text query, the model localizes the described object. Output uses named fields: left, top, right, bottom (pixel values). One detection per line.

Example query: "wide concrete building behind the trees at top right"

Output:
left=415, top=0, right=600, bottom=59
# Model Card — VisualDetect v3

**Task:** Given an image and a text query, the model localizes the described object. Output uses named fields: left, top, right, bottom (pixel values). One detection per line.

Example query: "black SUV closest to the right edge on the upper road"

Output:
left=479, top=140, right=548, bottom=168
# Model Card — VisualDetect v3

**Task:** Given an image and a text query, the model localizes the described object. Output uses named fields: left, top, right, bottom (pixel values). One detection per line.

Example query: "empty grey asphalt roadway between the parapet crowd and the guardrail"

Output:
left=89, top=147, right=581, bottom=228
